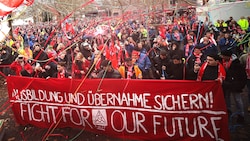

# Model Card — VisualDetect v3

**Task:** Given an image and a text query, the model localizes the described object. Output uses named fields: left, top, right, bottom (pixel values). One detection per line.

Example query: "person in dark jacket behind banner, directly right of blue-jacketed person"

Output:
left=152, top=50, right=170, bottom=80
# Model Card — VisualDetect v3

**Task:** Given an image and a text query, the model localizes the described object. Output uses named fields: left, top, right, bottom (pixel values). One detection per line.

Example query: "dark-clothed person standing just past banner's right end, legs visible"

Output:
left=221, top=50, right=247, bottom=123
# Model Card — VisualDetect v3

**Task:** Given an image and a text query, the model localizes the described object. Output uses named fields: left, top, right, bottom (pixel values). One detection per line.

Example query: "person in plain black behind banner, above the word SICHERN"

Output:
left=167, top=55, right=184, bottom=80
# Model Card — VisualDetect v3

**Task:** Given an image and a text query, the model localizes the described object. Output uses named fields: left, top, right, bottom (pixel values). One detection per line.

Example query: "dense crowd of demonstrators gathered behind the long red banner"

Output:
left=0, top=6, right=250, bottom=122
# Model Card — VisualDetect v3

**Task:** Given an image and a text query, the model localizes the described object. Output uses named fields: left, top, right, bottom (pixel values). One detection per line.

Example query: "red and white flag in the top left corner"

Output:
left=0, top=0, right=24, bottom=16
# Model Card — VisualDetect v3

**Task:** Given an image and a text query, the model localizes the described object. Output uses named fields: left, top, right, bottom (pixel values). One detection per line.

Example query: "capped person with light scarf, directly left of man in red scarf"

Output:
left=185, top=45, right=206, bottom=80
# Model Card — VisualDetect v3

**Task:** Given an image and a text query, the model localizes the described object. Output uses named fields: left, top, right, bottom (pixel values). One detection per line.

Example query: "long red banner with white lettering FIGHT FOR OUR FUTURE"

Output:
left=7, top=76, right=229, bottom=141
